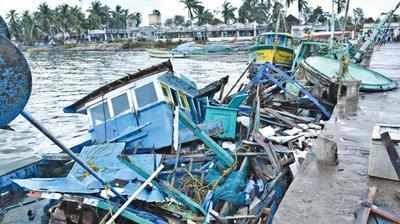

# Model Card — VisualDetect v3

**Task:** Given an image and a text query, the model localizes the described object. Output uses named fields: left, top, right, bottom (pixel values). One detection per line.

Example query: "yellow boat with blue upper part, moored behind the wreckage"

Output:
left=250, top=32, right=295, bottom=68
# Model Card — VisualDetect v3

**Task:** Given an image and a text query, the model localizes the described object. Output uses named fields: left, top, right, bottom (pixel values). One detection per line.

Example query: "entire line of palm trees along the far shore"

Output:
left=6, top=0, right=392, bottom=45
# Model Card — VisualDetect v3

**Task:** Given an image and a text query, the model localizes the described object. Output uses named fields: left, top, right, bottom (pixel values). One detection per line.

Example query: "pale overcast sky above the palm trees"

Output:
left=0, top=0, right=398, bottom=25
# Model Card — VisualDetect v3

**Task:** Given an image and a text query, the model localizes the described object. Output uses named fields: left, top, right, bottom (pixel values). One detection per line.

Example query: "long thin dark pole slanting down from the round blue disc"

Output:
left=21, top=111, right=125, bottom=200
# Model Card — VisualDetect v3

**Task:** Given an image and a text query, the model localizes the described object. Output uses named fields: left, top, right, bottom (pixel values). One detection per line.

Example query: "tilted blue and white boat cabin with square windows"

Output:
left=64, top=62, right=219, bottom=151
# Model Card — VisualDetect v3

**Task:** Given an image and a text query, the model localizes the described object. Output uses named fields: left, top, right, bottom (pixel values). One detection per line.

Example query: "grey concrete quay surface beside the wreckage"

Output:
left=274, top=44, right=400, bottom=224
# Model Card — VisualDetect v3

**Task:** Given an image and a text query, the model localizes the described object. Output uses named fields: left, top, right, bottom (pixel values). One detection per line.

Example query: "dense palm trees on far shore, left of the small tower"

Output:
left=6, top=0, right=142, bottom=45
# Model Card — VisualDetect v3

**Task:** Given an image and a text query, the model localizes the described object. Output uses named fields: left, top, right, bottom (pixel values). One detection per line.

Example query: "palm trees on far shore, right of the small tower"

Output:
left=165, top=0, right=373, bottom=31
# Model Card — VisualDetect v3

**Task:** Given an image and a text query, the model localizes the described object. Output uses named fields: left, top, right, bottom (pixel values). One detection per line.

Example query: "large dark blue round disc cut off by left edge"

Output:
left=0, top=35, right=32, bottom=128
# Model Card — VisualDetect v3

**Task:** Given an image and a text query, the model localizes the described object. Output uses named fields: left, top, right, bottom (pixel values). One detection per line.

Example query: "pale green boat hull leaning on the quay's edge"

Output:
left=301, top=56, right=398, bottom=92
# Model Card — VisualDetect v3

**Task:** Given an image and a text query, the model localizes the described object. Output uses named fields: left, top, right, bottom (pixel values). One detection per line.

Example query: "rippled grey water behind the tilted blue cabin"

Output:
left=0, top=51, right=247, bottom=167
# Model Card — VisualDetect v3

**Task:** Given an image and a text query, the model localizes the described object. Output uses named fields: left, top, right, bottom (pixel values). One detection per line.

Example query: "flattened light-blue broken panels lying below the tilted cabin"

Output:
left=13, top=143, right=165, bottom=202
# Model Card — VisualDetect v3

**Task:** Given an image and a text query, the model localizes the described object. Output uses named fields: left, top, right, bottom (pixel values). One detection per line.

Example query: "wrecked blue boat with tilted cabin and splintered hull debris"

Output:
left=7, top=61, right=293, bottom=224
